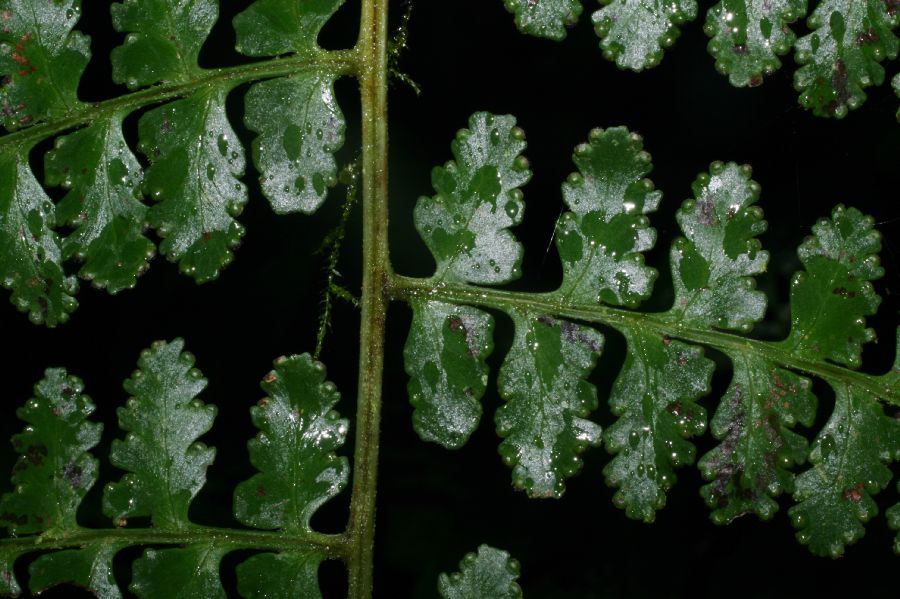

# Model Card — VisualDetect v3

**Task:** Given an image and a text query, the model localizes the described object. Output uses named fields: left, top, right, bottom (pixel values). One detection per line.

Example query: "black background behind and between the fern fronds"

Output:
left=0, top=0, right=900, bottom=598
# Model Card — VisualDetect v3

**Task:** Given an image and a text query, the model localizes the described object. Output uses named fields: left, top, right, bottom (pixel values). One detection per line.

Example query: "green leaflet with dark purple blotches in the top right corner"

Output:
left=794, top=0, right=900, bottom=118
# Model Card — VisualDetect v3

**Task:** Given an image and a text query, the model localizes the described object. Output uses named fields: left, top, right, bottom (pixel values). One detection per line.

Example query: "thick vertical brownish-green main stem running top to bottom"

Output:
left=347, top=0, right=391, bottom=599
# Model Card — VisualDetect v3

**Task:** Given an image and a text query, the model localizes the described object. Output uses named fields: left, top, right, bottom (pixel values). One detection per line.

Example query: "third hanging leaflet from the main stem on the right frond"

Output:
left=603, top=331, right=713, bottom=522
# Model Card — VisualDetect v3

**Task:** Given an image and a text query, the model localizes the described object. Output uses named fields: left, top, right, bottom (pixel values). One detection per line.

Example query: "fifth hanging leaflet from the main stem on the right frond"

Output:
left=789, top=384, right=900, bottom=557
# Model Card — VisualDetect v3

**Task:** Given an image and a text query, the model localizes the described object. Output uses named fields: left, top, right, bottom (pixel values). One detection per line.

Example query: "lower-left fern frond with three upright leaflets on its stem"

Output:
left=0, top=339, right=349, bottom=599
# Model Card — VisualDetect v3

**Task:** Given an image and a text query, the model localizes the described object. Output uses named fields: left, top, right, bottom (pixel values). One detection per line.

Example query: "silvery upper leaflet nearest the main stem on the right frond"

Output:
left=414, top=112, right=531, bottom=284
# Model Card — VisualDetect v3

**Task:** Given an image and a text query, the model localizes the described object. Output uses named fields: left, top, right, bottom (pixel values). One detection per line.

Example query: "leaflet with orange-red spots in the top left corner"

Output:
left=0, top=0, right=91, bottom=130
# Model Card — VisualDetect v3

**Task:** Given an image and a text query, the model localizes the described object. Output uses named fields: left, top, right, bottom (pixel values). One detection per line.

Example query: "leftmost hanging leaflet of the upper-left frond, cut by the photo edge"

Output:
left=0, top=148, right=78, bottom=327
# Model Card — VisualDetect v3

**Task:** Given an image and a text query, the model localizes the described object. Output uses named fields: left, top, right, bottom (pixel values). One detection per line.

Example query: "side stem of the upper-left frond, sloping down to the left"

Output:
left=0, top=50, right=358, bottom=152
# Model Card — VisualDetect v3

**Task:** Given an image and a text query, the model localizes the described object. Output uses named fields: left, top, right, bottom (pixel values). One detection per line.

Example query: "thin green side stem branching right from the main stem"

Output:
left=391, top=275, right=900, bottom=406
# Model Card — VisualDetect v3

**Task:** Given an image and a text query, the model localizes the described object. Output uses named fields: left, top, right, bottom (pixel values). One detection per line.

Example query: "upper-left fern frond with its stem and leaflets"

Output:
left=0, top=0, right=354, bottom=326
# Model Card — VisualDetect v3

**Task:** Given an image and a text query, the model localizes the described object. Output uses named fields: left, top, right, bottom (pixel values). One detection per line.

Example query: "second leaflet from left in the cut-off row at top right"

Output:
left=592, top=0, right=697, bottom=71
